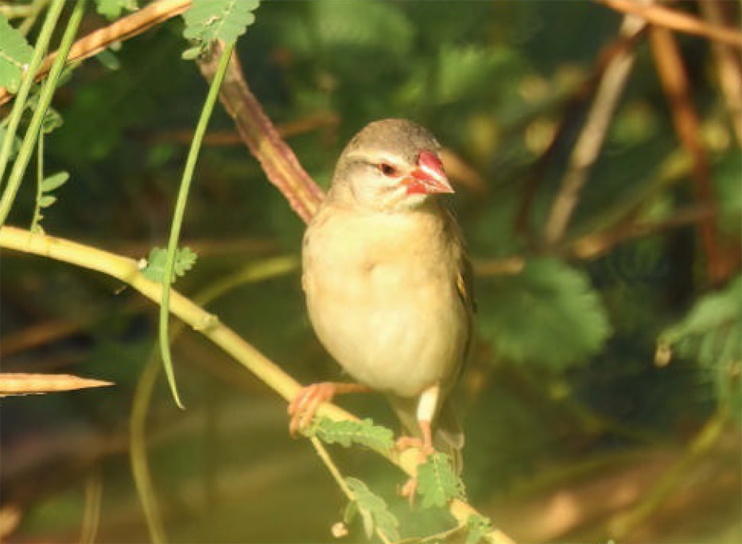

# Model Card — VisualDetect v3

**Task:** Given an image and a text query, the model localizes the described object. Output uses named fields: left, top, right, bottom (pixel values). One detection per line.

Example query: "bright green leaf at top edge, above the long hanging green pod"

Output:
left=183, top=0, right=260, bottom=44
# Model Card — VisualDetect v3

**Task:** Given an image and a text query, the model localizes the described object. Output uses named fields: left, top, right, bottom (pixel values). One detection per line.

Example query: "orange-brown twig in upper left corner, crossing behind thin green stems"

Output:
left=0, top=0, right=191, bottom=105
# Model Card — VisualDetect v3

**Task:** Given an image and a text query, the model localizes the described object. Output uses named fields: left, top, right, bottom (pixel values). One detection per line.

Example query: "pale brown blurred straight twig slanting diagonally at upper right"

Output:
left=544, top=10, right=645, bottom=245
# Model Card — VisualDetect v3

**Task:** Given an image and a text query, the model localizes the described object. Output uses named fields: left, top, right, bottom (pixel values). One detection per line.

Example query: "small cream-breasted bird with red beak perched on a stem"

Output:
left=289, top=119, right=474, bottom=480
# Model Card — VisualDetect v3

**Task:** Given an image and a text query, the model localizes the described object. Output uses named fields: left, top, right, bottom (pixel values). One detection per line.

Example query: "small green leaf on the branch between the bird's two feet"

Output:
left=304, top=417, right=394, bottom=454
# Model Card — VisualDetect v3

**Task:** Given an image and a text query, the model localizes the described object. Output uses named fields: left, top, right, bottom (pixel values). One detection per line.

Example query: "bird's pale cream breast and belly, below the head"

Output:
left=303, top=206, right=468, bottom=396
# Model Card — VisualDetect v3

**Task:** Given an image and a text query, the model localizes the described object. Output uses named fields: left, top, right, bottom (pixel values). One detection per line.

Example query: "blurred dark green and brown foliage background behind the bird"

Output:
left=0, top=0, right=742, bottom=543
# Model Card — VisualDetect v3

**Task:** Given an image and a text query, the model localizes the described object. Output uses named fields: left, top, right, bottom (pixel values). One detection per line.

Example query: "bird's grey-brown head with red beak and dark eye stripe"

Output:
left=332, top=119, right=454, bottom=211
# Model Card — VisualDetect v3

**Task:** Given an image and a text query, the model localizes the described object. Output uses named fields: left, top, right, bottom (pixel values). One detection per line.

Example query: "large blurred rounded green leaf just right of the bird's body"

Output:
left=479, top=258, right=611, bottom=370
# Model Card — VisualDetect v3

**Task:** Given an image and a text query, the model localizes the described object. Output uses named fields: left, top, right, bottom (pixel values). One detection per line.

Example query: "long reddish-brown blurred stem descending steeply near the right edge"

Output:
left=649, top=23, right=736, bottom=284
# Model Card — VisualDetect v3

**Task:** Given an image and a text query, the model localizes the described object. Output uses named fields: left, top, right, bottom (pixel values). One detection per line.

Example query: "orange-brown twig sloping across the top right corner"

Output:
left=593, top=0, right=742, bottom=48
